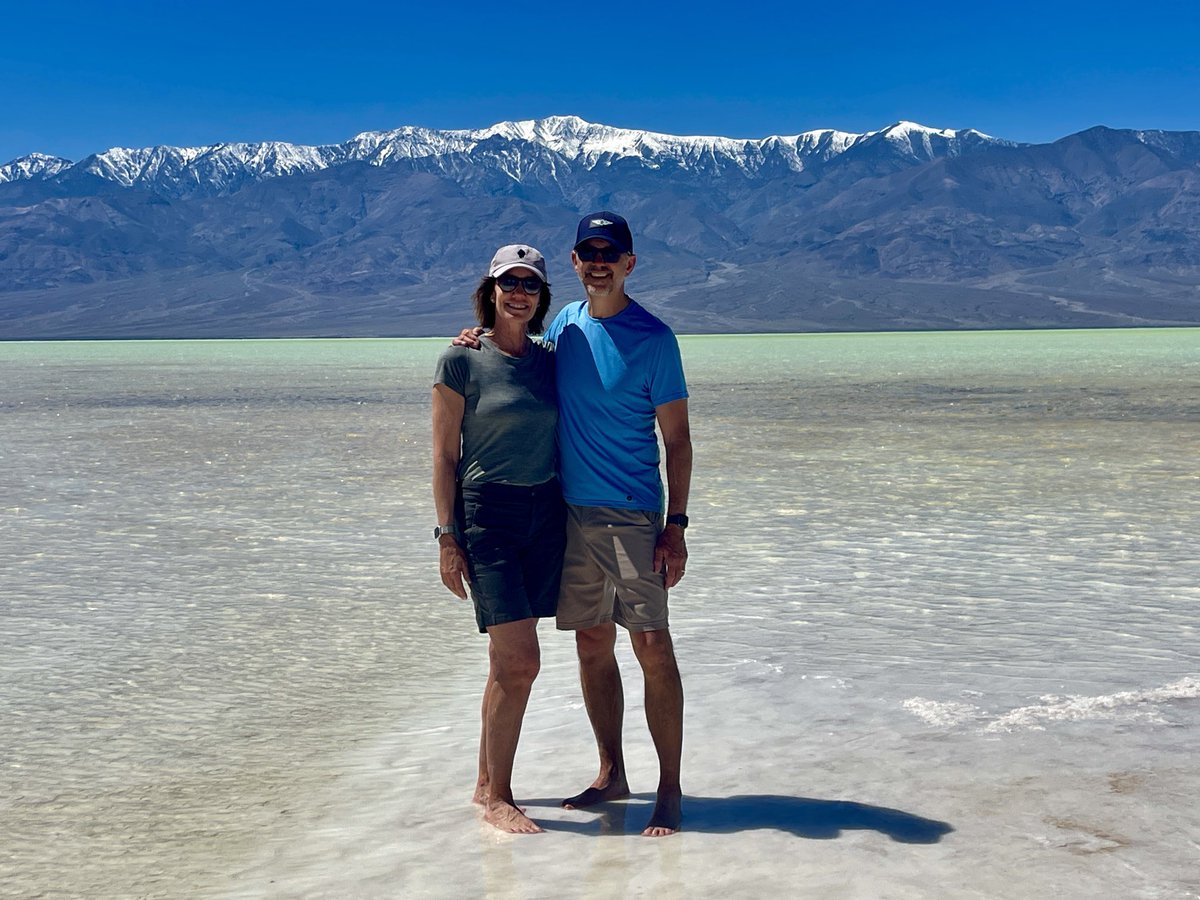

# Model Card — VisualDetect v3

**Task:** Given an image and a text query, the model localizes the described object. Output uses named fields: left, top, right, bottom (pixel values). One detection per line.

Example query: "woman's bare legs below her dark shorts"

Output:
left=484, top=619, right=541, bottom=834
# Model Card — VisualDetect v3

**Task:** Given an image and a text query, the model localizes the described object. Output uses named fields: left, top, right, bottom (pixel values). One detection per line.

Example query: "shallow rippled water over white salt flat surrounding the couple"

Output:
left=0, top=330, right=1200, bottom=898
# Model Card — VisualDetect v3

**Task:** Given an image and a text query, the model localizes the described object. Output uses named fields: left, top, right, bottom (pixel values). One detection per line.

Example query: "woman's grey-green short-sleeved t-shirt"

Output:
left=433, top=337, right=558, bottom=485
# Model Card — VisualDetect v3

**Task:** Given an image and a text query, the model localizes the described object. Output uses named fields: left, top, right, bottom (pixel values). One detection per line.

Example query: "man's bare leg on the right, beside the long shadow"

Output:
left=630, top=629, right=683, bottom=838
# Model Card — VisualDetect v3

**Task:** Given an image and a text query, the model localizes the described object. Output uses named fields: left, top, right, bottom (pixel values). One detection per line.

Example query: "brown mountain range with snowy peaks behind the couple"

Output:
left=0, top=116, right=1200, bottom=340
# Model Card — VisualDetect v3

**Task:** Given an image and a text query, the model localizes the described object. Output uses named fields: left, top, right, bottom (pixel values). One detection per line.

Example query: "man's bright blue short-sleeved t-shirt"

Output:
left=546, top=300, right=688, bottom=511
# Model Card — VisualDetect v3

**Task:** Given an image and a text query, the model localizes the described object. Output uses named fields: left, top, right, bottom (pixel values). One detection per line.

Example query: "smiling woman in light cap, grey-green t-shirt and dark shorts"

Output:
left=433, top=244, right=566, bottom=834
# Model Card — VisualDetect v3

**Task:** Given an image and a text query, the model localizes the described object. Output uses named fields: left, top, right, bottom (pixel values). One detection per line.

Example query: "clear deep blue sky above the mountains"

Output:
left=0, top=0, right=1200, bottom=162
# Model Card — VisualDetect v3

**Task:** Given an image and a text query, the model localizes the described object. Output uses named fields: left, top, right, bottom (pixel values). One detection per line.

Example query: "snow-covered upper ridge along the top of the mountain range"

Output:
left=0, top=116, right=1012, bottom=198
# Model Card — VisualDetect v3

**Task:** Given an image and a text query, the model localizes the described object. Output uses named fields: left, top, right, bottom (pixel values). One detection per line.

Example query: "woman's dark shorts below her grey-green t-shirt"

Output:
left=458, top=479, right=566, bottom=631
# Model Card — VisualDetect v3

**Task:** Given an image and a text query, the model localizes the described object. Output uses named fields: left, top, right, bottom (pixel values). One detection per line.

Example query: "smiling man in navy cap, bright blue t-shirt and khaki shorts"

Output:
left=456, top=211, right=691, bottom=836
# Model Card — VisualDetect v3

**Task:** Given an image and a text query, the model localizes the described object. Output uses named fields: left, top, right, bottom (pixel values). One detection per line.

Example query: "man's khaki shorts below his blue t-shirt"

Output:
left=557, top=505, right=667, bottom=631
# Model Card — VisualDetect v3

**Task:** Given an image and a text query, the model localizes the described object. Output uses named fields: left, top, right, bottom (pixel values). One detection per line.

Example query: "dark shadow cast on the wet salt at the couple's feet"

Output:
left=522, top=793, right=954, bottom=844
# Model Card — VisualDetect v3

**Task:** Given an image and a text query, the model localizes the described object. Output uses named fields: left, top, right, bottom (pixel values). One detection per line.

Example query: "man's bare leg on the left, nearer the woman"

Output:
left=563, top=622, right=629, bottom=809
